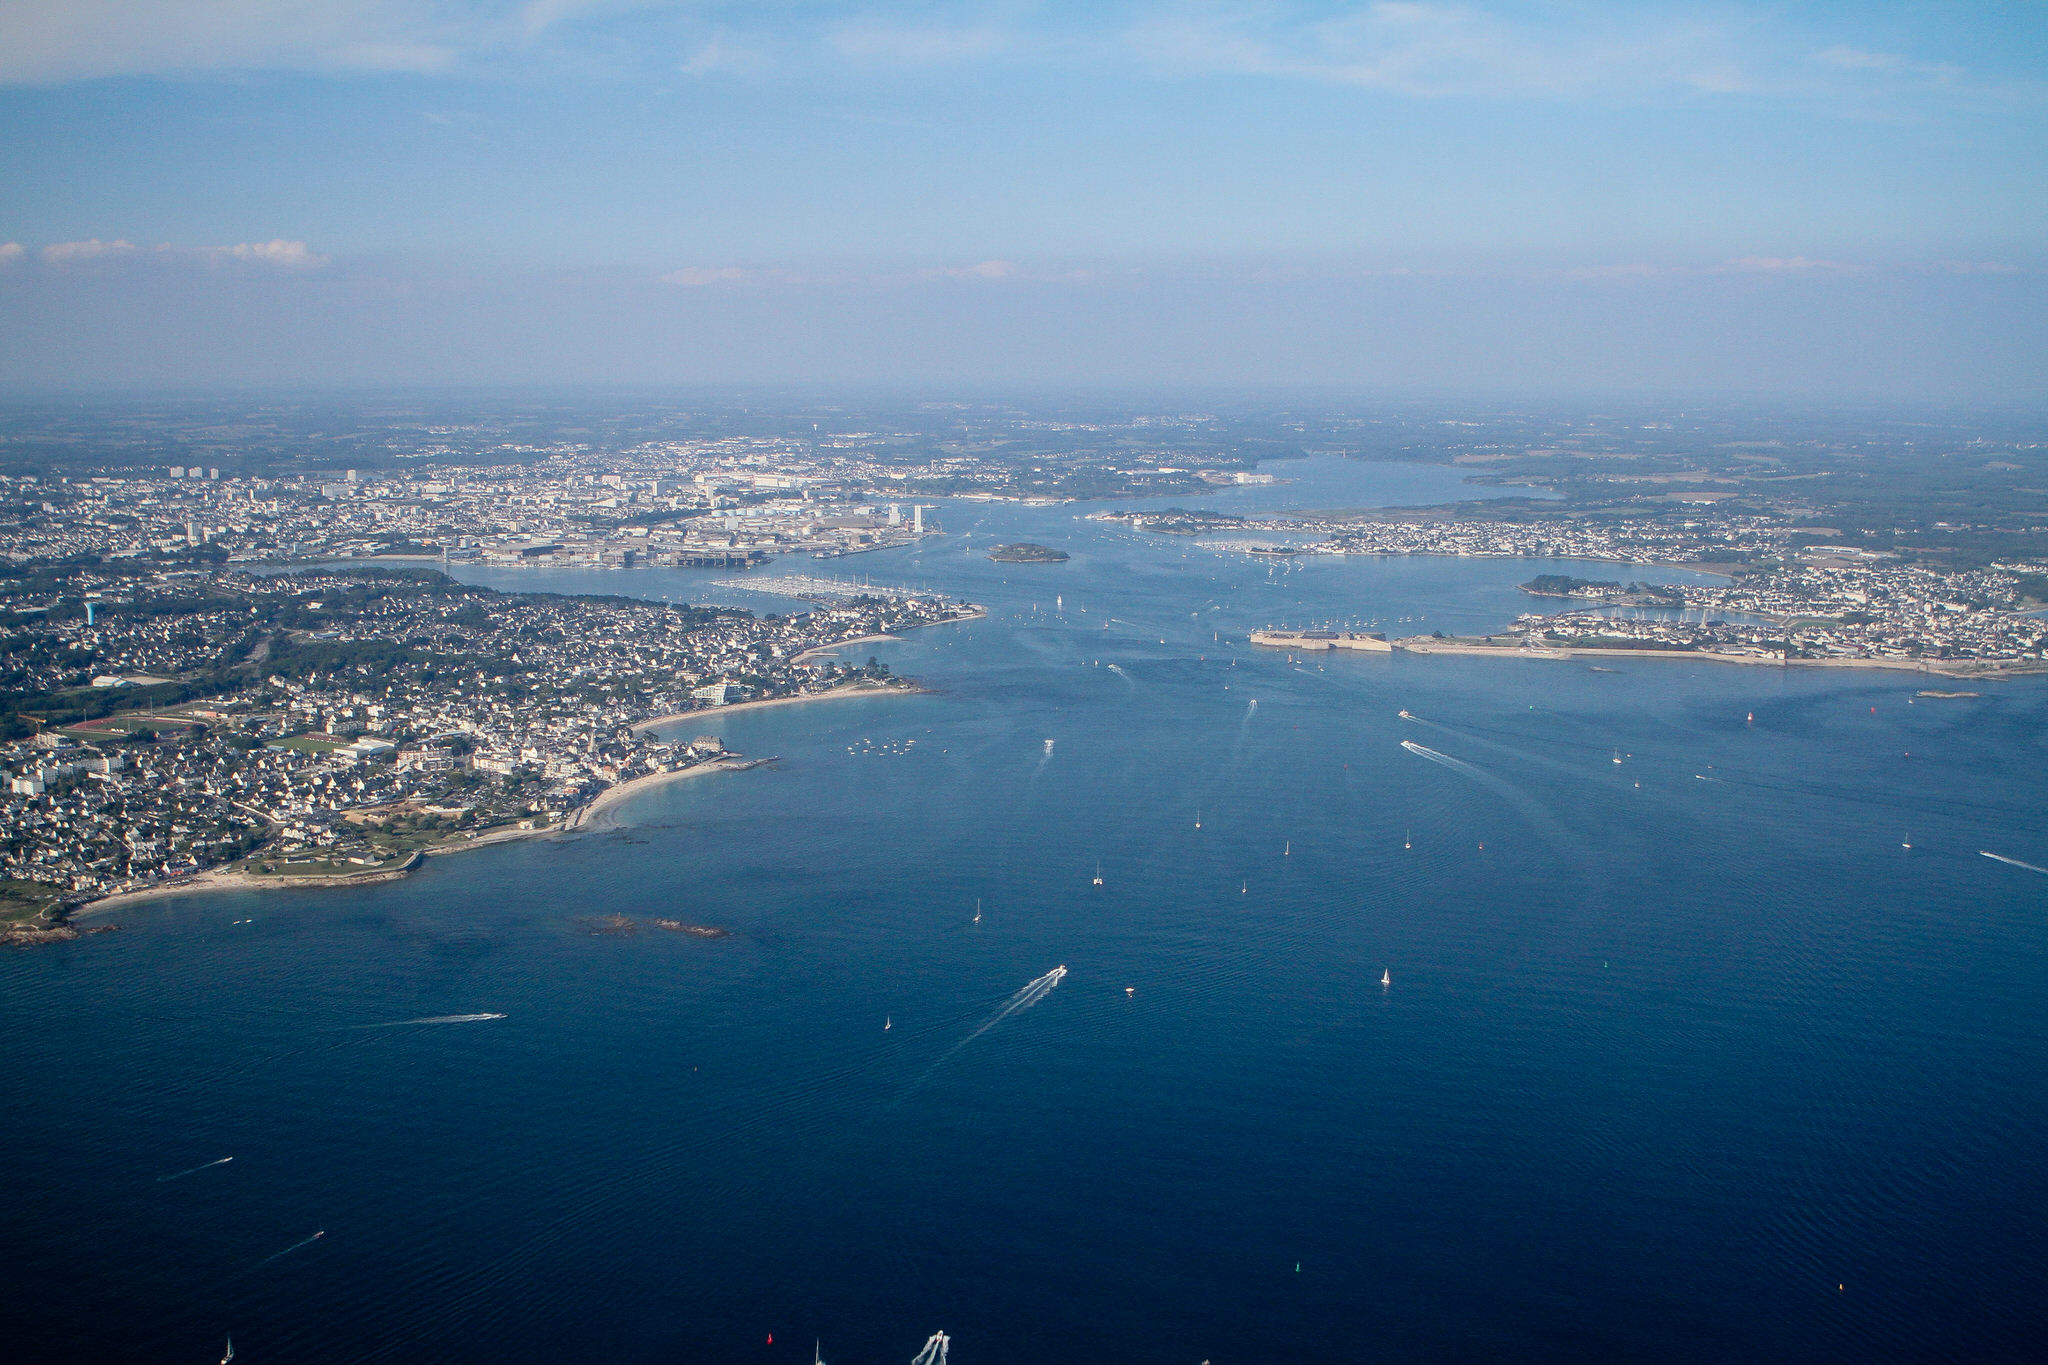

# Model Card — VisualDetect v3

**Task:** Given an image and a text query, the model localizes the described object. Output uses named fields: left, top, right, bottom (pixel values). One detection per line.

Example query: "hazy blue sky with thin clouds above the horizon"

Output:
left=0, top=0, right=2048, bottom=397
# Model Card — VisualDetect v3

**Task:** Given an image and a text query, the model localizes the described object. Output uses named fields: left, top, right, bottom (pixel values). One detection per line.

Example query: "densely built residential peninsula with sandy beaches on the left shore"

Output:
left=0, top=567, right=973, bottom=898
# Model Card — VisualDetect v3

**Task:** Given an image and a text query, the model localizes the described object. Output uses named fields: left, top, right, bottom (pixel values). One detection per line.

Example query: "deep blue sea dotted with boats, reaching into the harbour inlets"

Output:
left=0, top=465, right=2048, bottom=1365
